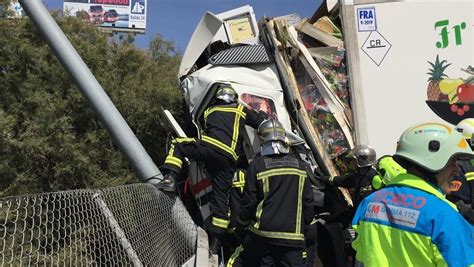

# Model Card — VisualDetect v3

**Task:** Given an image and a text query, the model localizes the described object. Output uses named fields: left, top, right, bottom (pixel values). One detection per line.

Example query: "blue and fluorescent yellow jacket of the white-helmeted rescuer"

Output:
left=352, top=174, right=474, bottom=266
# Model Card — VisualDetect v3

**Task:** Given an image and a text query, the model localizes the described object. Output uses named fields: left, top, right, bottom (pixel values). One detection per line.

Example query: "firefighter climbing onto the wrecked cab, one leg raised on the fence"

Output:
left=157, top=85, right=264, bottom=253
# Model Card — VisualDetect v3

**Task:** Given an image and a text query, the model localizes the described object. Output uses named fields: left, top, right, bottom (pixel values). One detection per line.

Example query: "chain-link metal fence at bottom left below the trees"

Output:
left=0, top=184, right=197, bottom=266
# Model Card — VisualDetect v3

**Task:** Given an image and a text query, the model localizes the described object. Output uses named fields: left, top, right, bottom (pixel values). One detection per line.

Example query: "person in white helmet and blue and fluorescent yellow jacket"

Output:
left=352, top=123, right=474, bottom=266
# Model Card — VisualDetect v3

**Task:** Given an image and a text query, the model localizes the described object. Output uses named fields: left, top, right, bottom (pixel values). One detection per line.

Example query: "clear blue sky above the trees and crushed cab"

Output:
left=43, top=0, right=321, bottom=52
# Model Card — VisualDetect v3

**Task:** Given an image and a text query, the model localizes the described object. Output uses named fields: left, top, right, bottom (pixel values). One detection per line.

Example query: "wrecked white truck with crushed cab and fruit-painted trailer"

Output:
left=165, top=0, right=474, bottom=265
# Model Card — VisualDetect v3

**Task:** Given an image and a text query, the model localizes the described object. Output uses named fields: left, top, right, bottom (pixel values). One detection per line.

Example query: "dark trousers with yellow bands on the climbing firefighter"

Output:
left=163, top=138, right=235, bottom=236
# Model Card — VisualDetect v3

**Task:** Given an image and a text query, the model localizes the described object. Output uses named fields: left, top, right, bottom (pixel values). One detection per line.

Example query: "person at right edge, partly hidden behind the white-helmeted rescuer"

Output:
left=447, top=118, right=474, bottom=224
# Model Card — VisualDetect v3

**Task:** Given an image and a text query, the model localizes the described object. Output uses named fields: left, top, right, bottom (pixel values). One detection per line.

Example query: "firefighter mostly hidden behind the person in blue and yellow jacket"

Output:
left=316, top=145, right=378, bottom=266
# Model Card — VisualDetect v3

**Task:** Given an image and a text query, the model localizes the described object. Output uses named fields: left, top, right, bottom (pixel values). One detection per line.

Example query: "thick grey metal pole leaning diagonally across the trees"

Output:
left=20, top=0, right=162, bottom=183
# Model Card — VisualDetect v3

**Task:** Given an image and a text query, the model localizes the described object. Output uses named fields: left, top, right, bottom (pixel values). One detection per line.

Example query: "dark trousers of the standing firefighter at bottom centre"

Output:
left=227, top=231, right=306, bottom=267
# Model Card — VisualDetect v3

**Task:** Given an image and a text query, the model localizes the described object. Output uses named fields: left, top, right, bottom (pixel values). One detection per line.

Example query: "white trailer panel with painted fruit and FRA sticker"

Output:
left=336, top=0, right=474, bottom=155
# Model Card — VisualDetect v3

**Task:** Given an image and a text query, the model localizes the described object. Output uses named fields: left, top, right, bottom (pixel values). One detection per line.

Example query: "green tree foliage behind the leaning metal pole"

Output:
left=0, top=13, right=184, bottom=196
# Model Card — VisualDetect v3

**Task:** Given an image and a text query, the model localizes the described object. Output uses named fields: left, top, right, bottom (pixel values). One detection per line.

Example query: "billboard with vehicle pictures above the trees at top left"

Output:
left=64, top=0, right=147, bottom=32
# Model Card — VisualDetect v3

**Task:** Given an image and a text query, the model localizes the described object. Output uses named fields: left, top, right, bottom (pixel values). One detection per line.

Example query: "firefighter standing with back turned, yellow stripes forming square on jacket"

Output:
left=228, top=119, right=314, bottom=266
